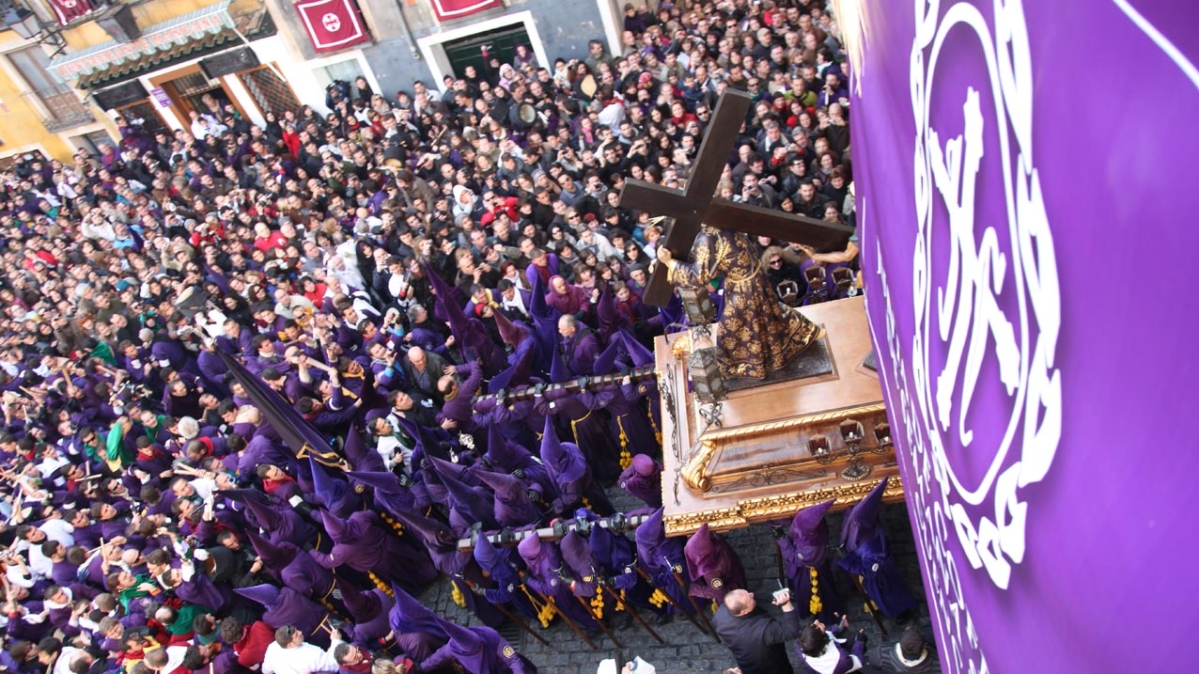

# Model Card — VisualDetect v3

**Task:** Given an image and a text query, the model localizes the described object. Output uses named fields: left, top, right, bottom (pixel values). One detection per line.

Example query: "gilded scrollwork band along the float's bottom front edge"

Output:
left=663, top=475, right=904, bottom=536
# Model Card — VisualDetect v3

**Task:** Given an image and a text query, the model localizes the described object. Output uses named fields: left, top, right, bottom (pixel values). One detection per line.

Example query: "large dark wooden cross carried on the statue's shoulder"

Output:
left=620, top=89, right=854, bottom=307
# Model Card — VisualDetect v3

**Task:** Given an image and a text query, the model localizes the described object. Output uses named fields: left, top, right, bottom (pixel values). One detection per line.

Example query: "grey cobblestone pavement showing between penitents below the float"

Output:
left=420, top=488, right=930, bottom=674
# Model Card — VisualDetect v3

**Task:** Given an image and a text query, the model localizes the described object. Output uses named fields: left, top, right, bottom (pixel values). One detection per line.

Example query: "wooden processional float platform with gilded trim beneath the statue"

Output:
left=655, top=296, right=903, bottom=536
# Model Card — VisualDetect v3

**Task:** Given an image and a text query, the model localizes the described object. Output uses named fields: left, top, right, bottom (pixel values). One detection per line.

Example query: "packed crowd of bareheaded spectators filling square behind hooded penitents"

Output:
left=0, top=0, right=855, bottom=674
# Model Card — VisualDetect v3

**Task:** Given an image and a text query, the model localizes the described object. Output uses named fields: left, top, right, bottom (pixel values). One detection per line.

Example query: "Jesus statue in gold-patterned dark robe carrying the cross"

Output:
left=658, top=225, right=820, bottom=379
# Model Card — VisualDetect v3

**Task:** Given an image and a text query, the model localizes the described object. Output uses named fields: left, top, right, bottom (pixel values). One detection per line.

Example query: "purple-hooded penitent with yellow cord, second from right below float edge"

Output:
left=778, top=499, right=840, bottom=625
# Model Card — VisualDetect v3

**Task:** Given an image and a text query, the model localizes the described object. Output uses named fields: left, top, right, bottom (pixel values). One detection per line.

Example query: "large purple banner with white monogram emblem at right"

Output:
left=839, top=0, right=1199, bottom=673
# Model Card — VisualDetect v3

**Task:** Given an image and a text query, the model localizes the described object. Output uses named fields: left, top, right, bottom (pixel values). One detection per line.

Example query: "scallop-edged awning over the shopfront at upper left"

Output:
left=50, top=0, right=273, bottom=89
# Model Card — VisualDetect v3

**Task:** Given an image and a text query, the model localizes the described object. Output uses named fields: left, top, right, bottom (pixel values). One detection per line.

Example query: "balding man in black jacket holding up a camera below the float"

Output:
left=712, top=590, right=800, bottom=674
